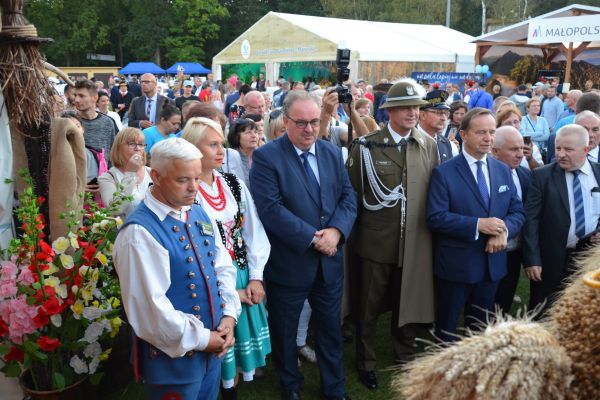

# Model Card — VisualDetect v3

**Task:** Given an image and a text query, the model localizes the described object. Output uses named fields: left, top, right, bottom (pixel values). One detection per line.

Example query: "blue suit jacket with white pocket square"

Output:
left=427, top=154, right=525, bottom=283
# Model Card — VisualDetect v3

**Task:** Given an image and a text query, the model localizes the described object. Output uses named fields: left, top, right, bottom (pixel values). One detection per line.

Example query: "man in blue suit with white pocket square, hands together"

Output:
left=427, top=108, right=525, bottom=341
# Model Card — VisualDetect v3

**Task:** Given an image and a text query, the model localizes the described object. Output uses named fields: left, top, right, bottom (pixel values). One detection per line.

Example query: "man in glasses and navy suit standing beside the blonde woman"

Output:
left=250, top=91, right=356, bottom=400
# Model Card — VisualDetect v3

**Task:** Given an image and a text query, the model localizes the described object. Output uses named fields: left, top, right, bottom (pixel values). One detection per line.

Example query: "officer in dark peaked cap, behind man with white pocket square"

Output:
left=419, top=90, right=458, bottom=163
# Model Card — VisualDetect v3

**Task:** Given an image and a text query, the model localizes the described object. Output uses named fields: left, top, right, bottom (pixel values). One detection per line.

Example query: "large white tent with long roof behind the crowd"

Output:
left=213, top=12, right=475, bottom=82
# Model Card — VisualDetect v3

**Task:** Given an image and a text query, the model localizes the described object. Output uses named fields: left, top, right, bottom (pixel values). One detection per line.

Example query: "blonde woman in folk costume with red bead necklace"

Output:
left=182, top=118, right=271, bottom=399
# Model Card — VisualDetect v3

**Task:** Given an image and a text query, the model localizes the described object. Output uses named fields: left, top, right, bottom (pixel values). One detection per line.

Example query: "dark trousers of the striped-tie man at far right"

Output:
left=529, top=249, right=581, bottom=320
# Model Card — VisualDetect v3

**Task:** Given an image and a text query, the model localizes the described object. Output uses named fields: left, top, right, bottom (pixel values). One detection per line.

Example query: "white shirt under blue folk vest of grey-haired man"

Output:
left=113, top=191, right=241, bottom=358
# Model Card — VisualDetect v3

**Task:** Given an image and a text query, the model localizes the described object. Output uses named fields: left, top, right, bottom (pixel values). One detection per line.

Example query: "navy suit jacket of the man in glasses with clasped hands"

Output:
left=250, top=134, right=356, bottom=287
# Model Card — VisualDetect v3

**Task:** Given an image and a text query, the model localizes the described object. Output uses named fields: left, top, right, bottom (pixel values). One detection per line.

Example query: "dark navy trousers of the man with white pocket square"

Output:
left=435, top=277, right=499, bottom=342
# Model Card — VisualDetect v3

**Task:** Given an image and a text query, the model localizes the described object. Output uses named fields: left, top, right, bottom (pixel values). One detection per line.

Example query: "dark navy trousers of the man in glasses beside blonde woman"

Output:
left=266, top=267, right=345, bottom=397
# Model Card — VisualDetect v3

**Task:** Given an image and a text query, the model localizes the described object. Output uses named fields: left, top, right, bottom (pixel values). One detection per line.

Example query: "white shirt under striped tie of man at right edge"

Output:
left=565, top=160, right=598, bottom=248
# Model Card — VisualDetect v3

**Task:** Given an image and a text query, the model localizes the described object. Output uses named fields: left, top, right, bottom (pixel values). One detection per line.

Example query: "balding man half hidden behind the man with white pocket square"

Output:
left=492, top=125, right=531, bottom=314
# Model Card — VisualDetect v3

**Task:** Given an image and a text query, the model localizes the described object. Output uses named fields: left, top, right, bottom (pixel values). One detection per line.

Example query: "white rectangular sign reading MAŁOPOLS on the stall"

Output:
left=527, top=14, right=600, bottom=44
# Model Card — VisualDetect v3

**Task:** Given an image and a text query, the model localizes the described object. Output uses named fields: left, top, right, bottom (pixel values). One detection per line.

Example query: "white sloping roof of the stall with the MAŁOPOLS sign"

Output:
left=473, top=4, right=600, bottom=47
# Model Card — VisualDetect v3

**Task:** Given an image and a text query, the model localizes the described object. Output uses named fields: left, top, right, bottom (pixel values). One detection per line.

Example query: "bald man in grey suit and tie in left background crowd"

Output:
left=129, top=74, right=174, bottom=129
